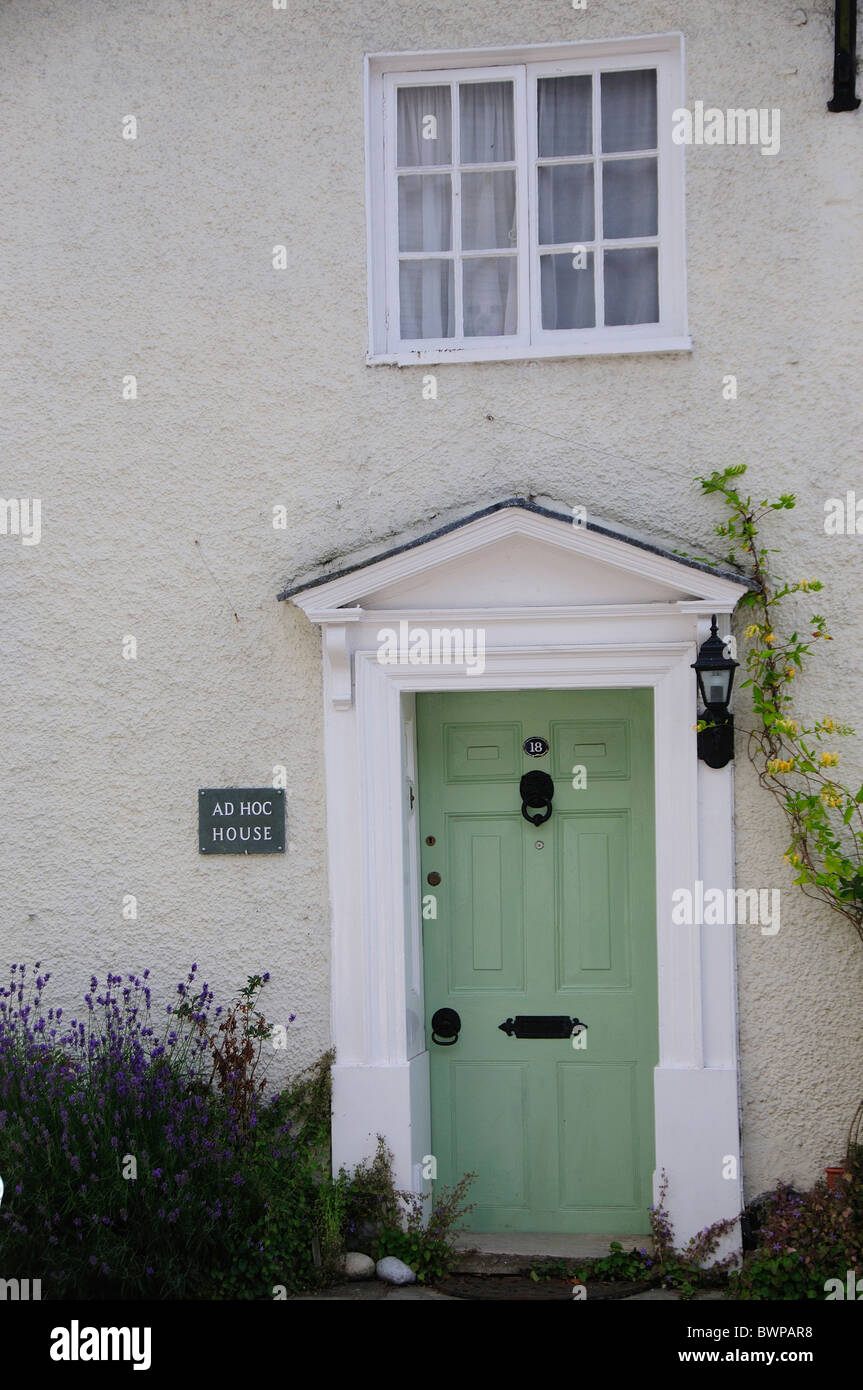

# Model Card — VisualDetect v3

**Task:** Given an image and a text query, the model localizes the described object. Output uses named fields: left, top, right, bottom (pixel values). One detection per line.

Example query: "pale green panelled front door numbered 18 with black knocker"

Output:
left=417, top=689, right=657, bottom=1234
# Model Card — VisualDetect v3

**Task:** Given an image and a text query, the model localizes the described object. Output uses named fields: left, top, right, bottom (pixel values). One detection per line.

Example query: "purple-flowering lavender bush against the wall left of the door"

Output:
left=0, top=962, right=321, bottom=1298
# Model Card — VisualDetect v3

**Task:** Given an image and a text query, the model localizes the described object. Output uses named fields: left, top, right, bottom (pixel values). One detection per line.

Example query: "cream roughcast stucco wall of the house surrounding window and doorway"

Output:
left=0, top=0, right=863, bottom=1193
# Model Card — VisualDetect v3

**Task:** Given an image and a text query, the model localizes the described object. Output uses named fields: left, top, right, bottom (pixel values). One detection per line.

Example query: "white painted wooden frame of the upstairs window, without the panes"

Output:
left=365, top=33, right=692, bottom=367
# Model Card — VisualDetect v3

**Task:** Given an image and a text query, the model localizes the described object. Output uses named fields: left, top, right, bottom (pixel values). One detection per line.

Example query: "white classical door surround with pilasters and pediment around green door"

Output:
left=279, top=498, right=745, bottom=1243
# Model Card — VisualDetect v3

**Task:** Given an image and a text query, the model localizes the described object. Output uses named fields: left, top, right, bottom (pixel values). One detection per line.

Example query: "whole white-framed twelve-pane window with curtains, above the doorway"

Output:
left=368, top=36, right=689, bottom=364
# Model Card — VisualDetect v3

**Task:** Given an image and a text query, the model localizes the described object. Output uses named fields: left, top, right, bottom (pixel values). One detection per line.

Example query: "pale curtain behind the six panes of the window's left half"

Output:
left=397, top=82, right=518, bottom=339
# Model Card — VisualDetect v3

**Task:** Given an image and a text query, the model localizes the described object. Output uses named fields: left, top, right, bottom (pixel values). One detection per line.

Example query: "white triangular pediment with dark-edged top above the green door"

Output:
left=279, top=498, right=748, bottom=619
